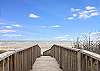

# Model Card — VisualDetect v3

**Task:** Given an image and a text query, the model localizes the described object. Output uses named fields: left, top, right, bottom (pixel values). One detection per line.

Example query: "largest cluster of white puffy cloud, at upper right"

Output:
left=67, top=6, right=100, bottom=20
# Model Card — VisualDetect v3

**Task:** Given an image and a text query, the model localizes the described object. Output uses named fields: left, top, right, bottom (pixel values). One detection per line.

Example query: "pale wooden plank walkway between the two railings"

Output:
left=31, top=56, right=62, bottom=71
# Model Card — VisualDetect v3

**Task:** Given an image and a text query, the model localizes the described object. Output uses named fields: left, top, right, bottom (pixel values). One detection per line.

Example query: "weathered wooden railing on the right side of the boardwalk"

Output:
left=43, top=45, right=100, bottom=71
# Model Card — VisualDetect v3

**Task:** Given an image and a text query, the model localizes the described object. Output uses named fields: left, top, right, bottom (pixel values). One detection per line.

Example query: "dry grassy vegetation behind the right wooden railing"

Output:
left=74, top=36, right=100, bottom=54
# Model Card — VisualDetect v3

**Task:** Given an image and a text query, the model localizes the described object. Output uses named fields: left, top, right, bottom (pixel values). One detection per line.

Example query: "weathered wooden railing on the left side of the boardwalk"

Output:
left=0, top=45, right=41, bottom=71
